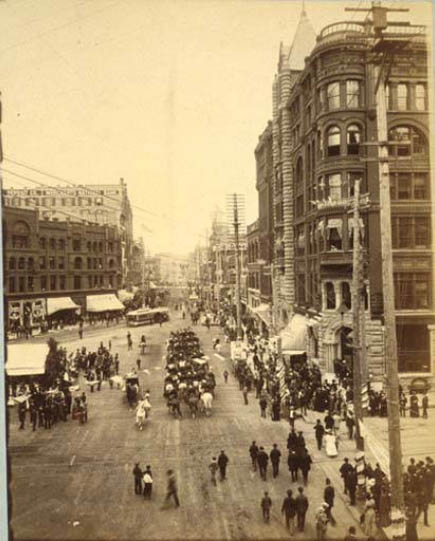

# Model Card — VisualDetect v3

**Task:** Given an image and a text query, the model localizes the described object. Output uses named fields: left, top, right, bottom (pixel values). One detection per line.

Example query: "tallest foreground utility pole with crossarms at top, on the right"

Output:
left=346, top=1, right=422, bottom=528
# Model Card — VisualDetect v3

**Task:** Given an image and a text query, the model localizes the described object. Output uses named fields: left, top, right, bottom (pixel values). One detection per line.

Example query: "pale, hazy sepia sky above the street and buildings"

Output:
left=0, top=0, right=431, bottom=253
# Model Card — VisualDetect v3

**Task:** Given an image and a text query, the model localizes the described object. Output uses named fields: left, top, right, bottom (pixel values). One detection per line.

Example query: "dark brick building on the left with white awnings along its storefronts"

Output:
left=3, top=207, right=122, bottom=328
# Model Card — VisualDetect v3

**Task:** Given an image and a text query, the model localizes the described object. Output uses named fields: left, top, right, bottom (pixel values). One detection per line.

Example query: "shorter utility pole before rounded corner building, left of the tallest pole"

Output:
left=352, top=179, right=365, bottom=451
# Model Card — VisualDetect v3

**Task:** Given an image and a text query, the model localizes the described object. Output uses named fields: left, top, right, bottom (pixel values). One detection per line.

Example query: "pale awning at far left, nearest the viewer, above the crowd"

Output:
left=6, top=344, right=48, bottom=376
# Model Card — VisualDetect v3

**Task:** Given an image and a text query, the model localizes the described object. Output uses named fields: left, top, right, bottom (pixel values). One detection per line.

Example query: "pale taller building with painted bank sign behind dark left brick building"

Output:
left=2, top=179, right=133, bottom=286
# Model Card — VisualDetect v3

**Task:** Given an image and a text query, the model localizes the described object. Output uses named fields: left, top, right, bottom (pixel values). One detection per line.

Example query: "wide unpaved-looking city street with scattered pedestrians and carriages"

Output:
left=9, top=315, right=366, bottom=540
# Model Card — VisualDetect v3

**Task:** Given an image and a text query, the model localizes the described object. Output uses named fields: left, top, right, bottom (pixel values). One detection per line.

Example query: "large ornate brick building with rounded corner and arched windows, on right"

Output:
left=273, top=7, right=435, bottom=379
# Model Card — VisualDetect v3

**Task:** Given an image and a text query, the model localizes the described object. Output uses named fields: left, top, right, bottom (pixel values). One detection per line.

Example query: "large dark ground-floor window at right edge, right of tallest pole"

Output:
left=396, top=324, right=431, bottom=372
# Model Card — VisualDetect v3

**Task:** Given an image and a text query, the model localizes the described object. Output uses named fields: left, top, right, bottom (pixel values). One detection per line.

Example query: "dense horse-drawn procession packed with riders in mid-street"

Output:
left=163, top=328, right=216, bottom=417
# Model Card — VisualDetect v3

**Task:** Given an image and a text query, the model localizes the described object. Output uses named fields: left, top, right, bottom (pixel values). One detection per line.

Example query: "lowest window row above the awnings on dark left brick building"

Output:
left=8, top=274, right=122, bottom=293
